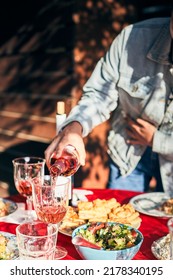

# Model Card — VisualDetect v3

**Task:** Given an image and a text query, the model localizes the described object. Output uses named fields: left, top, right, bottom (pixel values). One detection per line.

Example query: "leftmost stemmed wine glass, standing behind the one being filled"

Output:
left=12, top=156, right=45, bottom=220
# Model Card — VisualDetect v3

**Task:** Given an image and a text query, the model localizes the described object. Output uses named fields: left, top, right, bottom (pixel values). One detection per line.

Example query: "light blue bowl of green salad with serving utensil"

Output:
left=72, top=222, right=144, bottom=260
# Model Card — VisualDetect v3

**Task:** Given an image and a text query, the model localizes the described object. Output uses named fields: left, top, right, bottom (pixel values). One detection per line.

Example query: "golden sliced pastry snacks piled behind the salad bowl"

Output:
left=59, top=198, right=141, bottom=235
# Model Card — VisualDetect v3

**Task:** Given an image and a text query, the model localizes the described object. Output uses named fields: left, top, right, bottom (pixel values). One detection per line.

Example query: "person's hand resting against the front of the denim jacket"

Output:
left=126, top=117, right=157, bottom=147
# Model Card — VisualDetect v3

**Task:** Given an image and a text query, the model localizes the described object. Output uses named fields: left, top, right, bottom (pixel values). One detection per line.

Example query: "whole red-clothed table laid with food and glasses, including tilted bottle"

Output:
left=0, top=145, right=173, bottom=260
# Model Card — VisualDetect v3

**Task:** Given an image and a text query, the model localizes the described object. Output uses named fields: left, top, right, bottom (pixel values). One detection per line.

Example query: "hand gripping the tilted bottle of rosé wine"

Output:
left=44, top=122, right=86, bottom=167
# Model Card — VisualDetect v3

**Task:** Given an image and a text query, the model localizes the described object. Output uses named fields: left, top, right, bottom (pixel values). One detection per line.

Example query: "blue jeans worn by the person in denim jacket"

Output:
left=107, top=148, right=163, bottom=192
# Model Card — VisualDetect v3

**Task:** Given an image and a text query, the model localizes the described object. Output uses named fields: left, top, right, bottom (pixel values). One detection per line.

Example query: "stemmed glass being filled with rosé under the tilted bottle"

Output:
left=32, top=176, right=70, bottom=259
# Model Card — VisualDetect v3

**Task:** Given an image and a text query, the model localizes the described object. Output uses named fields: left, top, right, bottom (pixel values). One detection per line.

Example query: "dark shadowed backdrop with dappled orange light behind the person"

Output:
left=0, top=0, right=172, bottom=197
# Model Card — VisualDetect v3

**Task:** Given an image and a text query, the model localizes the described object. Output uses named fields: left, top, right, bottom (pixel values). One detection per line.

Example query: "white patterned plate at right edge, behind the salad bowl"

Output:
left=129, top=192, right=173, bottom=218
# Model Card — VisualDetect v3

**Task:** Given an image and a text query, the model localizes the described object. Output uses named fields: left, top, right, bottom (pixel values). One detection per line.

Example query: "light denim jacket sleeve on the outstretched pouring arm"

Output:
left=61, top=31, right=127, bottom=137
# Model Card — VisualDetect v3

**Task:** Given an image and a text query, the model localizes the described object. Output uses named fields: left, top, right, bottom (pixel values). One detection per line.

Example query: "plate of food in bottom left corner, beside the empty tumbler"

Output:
left=0, top=231, right=19, bottom=260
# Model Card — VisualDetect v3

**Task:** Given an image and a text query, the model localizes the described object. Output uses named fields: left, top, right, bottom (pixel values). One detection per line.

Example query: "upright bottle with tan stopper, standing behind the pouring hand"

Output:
left=55, top=101, right=73, bottom=205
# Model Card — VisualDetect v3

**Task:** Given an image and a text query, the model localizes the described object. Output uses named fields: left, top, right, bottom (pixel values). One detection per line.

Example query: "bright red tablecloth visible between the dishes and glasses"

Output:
left=0, top=189, right=168, bottom=260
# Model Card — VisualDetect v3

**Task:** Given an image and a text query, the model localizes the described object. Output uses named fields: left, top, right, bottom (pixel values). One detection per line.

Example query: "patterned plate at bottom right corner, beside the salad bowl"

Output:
left=151, top=234, right=170, bottom=260
